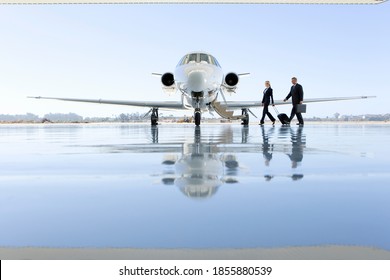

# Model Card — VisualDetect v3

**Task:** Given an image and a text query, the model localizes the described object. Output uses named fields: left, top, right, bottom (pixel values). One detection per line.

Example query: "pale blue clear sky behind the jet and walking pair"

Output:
left=0, top=2, right=390, bottom=117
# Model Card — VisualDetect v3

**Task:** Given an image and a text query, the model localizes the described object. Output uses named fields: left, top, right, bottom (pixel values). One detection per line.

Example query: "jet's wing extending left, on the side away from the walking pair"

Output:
left=28, top=96, right=186, bottom=110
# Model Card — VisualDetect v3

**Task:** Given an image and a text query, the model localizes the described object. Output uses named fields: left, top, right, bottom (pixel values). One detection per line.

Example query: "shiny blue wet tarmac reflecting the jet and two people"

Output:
left=0, top=124, right=390, bottom=250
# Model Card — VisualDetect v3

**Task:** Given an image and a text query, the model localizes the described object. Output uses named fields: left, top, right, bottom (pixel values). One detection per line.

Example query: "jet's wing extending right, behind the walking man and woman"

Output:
left=222, top=96, right=375, bottom=110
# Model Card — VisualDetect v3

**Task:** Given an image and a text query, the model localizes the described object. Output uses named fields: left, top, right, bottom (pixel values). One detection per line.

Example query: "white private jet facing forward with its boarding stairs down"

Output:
left=29, top=52, right=373, bottom=126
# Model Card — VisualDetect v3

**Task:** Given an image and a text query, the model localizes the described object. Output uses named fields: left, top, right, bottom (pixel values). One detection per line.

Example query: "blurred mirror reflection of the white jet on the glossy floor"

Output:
left=99, top=126, right=260, bottom=198
